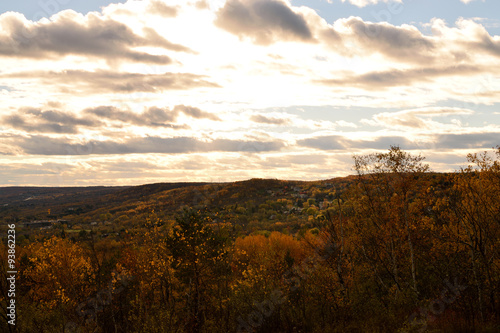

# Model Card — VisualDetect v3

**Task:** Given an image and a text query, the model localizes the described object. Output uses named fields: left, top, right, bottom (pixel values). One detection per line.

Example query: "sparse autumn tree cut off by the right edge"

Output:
left=448, top=147, right=500, bottom=321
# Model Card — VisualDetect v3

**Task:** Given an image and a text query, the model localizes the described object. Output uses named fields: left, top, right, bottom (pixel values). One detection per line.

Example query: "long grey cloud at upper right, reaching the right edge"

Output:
left=316, top=15, right=500, bottom=66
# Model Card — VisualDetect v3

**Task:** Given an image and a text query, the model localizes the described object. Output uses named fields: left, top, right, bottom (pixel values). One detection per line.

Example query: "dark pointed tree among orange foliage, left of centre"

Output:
left=116, top=211, right=179, bottom=332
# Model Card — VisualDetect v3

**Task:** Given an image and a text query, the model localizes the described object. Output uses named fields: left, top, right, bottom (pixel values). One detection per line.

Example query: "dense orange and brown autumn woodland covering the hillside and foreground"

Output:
left=0, top=147, right=500, bottom=333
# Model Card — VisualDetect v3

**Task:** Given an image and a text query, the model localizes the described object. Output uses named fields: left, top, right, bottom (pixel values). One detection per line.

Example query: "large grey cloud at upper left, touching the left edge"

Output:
left=0, top=10, right=192, bottom=64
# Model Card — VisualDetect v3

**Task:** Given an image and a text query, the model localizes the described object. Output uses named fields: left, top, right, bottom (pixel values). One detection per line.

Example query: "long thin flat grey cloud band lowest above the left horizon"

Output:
left=12, top=136, right=284, bottom=155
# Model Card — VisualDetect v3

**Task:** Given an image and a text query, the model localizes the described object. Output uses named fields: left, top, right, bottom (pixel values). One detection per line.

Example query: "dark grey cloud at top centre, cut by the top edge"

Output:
left=215, top=0, right=314, bottom=45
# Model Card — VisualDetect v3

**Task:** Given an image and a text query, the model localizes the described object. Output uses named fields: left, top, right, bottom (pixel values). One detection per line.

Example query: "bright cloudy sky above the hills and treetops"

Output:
left=0, top=0, right=500, bottom=186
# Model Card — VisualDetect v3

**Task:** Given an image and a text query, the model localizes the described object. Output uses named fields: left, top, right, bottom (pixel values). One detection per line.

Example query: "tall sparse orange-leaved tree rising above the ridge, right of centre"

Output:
left=354, top=146, right=429, bottom=299
